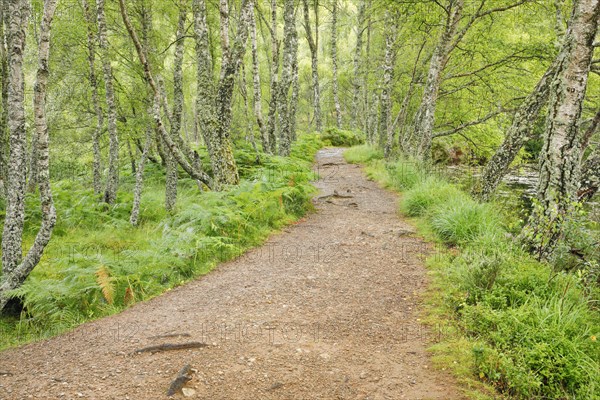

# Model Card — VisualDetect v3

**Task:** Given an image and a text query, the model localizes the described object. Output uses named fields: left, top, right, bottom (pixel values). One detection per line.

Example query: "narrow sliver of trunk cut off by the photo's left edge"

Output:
left=0, top=0, right=9, bottom=198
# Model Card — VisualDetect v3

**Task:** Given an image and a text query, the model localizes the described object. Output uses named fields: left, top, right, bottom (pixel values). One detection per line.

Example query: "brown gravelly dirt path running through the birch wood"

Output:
left=0, top=149, right=462, bottom=400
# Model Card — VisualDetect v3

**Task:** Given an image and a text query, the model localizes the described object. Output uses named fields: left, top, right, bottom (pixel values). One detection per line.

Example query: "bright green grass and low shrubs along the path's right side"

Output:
left=346, top=146, right=600, bottom=399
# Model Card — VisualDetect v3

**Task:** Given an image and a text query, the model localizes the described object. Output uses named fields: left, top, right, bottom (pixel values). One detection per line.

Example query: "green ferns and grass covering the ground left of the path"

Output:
left=0, top=135, right=322, bottom=348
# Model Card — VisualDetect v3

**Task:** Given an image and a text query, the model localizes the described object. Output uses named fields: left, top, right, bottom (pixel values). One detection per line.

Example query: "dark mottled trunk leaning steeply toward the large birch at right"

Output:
left=474, top=64, right=557, bottom=201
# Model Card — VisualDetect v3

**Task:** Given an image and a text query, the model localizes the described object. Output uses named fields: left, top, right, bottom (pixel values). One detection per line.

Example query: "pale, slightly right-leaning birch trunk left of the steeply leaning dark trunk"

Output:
left=415, top=0, right=464, bottom=160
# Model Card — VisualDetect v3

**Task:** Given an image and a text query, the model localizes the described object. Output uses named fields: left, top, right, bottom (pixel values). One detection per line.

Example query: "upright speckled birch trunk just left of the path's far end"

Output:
left=277, top=0, right=298, bottom=156
